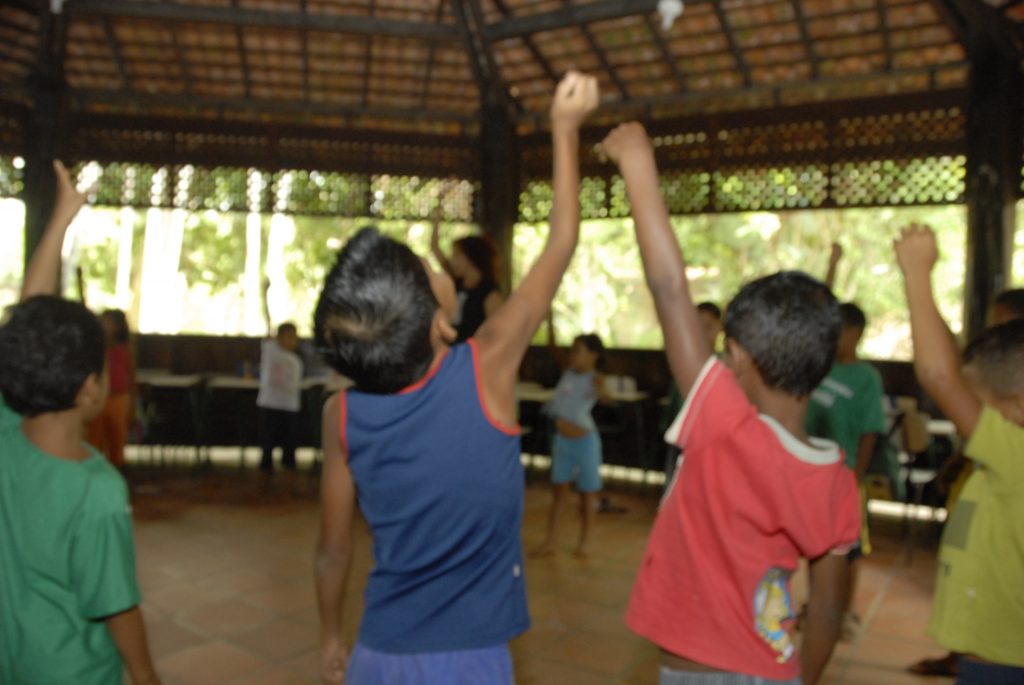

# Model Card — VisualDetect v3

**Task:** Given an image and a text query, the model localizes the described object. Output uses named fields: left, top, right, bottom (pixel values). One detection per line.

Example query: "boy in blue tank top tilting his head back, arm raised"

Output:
left=314, top=73, right=598, bottom=685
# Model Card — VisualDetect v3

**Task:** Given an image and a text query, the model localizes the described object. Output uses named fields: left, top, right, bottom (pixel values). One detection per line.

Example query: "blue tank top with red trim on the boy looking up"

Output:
left=341, top=340, right=529, bottom=653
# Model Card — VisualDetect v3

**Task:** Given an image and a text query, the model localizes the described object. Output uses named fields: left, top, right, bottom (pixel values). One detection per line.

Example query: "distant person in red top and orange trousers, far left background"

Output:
left=86, top=309, right=135, bottom=469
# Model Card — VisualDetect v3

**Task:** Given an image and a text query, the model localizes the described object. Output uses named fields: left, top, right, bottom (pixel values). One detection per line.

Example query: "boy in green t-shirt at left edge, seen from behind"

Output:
left=0, top=163, right=159, bottom=685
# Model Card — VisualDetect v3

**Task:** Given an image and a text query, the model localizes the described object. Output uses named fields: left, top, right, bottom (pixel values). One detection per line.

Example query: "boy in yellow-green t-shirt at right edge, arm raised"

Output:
left=896, top=224, right=1024, bottom=685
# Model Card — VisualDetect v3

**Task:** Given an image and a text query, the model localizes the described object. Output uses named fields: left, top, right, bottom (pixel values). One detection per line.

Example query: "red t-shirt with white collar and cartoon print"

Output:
left=626, top=357, right=860, bottom=680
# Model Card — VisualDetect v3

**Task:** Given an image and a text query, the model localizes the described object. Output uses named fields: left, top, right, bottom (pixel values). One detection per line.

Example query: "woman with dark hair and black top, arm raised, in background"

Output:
left=430, top=225, right=505, bottom=342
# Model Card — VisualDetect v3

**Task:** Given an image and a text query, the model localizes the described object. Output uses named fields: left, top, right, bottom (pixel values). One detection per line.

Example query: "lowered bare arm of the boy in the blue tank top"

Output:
left=315, top=395, right=355, bottom=683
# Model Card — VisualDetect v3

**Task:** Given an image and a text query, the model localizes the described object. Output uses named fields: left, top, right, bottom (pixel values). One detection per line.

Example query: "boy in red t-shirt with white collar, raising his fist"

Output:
left=602, top=123, right=860, bottom=685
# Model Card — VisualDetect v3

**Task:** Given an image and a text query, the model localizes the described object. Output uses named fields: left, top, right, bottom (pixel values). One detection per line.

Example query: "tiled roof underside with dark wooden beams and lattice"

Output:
left=0, top=0, right=1024, bottom=330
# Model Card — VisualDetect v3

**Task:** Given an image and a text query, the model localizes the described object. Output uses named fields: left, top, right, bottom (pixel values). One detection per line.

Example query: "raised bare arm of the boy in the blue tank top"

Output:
left=475, top=72, right=598, bottom=423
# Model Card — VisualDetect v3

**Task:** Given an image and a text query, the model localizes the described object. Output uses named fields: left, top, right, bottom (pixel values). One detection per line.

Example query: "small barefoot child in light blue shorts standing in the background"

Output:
left=534, top=333, right=607, bottom=557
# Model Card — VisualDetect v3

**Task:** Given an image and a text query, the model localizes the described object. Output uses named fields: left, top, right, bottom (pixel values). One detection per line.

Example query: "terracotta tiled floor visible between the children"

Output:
left=125, top=458, right=947, bottom=685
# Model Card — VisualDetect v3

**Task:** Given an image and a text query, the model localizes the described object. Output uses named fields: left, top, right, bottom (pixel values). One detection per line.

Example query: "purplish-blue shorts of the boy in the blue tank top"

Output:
left=345, top=643, right=515, bottom=685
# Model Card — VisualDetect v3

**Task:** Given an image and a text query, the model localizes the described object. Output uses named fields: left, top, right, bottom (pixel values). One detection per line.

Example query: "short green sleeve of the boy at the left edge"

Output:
left=71, top=472, right=140, bottom=619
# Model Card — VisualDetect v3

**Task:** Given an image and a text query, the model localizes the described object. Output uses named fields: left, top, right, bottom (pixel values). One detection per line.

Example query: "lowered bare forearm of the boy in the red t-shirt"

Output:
left=800, top=554, right=850, bottom=685
